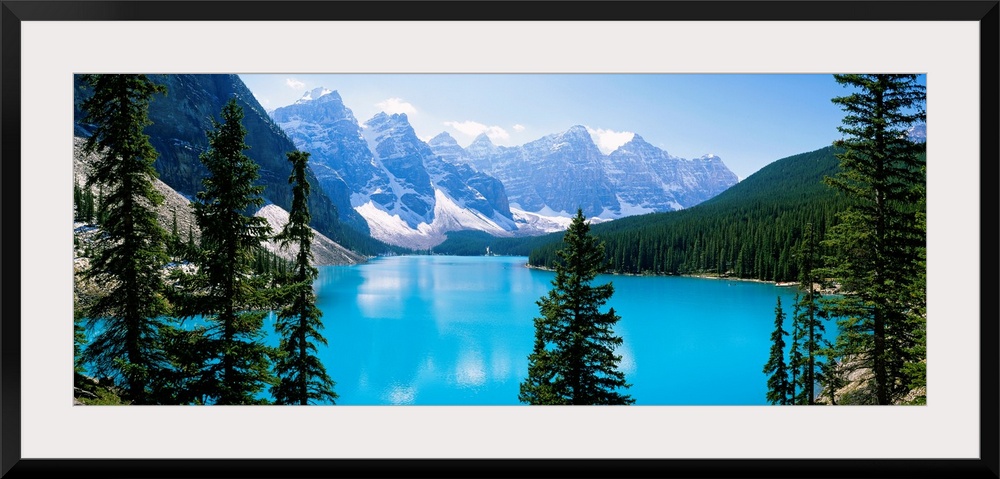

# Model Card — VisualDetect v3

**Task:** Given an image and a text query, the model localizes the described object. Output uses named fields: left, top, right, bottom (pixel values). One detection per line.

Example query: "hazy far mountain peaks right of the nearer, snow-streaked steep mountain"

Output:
left=430, top=126, right=738, bottom=219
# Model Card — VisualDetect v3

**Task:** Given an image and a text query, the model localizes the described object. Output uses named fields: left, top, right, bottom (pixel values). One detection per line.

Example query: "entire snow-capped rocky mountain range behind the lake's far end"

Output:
left=271, top=88, right=738, bottom=248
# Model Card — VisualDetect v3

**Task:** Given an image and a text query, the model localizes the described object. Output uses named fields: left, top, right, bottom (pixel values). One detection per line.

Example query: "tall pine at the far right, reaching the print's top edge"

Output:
left=826, top=75, right=926, bottom=404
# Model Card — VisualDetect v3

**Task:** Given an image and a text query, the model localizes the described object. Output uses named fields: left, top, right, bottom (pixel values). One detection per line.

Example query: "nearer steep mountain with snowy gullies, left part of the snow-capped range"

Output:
left=272, top=88, right=516, bottom=248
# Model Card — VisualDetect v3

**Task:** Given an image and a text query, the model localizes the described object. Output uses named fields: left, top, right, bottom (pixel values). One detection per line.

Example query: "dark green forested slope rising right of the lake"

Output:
left=529, top=147, right=847, bottom=281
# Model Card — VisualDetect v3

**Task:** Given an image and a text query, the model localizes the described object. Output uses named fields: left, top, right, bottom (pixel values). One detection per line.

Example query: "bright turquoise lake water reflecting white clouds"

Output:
left=274, top=256, right=804, bottom=405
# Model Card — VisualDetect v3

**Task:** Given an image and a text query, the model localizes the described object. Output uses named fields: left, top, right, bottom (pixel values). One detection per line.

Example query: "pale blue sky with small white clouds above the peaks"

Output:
left=240, top=73, right=924, bottom=179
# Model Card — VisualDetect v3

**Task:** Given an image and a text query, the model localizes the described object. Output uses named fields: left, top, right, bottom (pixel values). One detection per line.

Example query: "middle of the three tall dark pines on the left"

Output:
left=187, top=99, right=273, bottom=404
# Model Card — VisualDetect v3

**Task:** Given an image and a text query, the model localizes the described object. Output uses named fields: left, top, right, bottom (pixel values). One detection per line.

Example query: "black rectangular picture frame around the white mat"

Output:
left=0, top=0, right=1000, bottom=478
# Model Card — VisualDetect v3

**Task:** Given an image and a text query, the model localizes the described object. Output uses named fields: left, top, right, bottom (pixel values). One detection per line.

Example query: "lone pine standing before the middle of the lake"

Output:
left=518, top=209, right=635, bottom=405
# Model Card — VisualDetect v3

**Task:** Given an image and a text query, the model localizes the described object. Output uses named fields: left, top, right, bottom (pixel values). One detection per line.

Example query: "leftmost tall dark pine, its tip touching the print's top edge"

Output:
left=81, top=75, right=168, bottom=404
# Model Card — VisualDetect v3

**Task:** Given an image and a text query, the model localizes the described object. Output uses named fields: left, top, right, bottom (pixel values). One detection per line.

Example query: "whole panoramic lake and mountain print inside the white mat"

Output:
left=72, top=73, right=928, bottom=406
